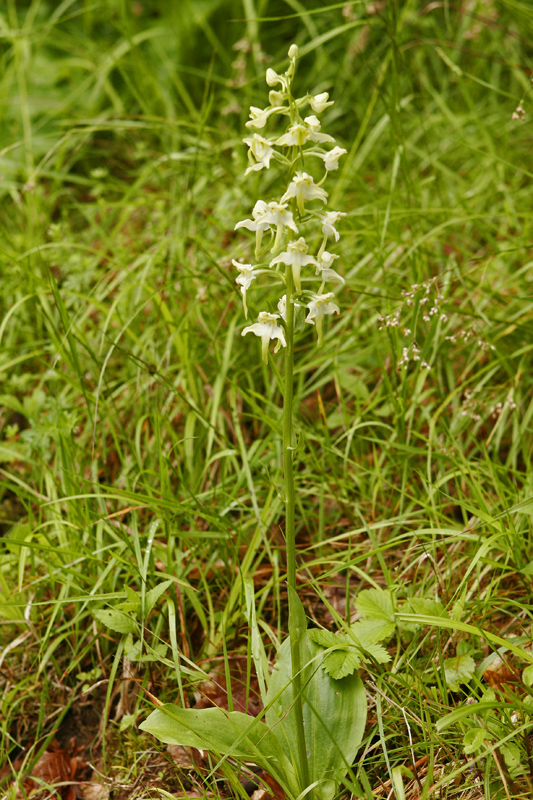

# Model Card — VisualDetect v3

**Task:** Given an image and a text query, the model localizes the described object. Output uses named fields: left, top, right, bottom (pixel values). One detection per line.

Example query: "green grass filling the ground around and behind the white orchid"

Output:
left=0, top=0, right=533, bottom=798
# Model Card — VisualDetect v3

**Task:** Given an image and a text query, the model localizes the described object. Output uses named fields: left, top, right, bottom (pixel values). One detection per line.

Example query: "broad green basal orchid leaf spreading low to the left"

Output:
left=139, top=703, right=299, bottom=796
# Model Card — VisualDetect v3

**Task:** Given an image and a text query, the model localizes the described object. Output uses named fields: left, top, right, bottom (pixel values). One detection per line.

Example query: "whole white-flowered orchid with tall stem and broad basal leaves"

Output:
left=141, top=45, right=368, bottom=800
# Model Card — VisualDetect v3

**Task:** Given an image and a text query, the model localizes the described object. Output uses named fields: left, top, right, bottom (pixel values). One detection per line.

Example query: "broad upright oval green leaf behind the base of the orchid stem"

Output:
left=266, top=633, right=366, bottom=800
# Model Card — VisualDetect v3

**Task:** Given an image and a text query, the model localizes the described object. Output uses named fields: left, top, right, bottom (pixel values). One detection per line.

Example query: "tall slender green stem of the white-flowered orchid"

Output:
left=283, top=266, right=309, bottom=789
